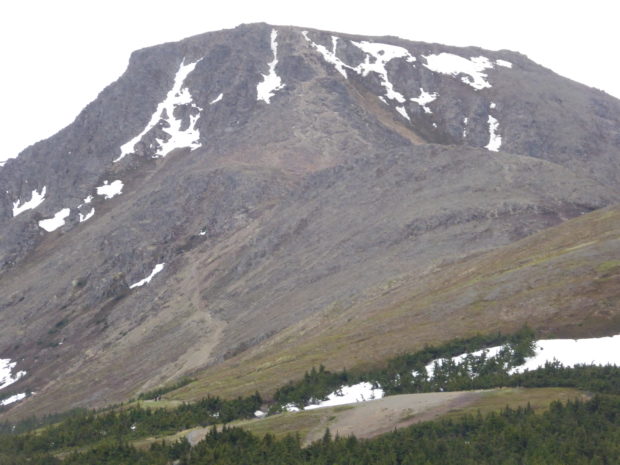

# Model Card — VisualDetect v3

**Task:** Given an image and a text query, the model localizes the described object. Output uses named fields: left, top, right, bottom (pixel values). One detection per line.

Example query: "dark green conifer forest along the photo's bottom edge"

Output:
left=0, top=396, right=620, bottom=465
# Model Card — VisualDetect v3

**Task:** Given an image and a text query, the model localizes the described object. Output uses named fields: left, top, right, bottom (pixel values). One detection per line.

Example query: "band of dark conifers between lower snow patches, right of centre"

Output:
left=271, top=328, right=620, bottom=412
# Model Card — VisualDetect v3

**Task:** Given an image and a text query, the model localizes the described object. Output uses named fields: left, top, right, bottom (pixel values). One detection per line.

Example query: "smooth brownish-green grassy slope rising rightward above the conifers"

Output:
left=167, top=206, right=620, bottom=400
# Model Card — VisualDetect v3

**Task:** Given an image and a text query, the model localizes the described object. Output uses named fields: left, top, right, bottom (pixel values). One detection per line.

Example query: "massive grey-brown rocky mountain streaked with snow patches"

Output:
left=0, top=24, right=620, bottom=416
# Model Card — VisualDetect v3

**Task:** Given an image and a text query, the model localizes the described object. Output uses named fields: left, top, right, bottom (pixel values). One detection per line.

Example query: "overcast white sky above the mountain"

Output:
left=0, top=0, right=620, bottom=160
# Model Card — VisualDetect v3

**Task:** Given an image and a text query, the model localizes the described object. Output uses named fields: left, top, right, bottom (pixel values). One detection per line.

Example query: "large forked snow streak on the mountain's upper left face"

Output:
left=114, top=59, right=202, bottom=163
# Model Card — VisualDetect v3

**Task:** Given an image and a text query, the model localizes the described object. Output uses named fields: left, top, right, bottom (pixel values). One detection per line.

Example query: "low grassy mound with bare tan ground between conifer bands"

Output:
left=127, top=388, right=588, bottom=449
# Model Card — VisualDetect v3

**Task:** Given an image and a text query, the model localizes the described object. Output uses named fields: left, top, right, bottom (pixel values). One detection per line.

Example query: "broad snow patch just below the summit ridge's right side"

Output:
left=424, top=52, right=493, bottom=90
